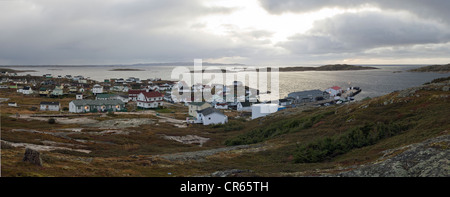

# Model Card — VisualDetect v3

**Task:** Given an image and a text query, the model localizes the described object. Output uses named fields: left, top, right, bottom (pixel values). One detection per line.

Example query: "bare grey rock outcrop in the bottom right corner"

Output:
left=337, top=135, right=450, bottom=177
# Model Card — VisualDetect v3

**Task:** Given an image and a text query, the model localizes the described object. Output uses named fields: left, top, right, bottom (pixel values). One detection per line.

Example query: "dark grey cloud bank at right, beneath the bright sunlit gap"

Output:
left=279, top=12, right=450, bottom=54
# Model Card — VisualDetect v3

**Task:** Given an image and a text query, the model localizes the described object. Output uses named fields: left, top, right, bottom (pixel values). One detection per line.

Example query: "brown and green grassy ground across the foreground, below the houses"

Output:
left=1, top=78, right=450, bottom=177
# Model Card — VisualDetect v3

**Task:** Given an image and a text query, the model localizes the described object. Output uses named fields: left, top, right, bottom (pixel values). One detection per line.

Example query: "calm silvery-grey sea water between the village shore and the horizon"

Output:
left=2, top=65, right=450, bottom=100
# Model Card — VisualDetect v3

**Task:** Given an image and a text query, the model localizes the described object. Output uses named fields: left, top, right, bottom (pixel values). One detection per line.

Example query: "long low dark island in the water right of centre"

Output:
left=279, top=64, right=378, bottom=72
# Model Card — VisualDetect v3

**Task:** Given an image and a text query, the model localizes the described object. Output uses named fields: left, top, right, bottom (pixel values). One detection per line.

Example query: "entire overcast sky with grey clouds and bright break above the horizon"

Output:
left=0, top=0, right=450, bottom=65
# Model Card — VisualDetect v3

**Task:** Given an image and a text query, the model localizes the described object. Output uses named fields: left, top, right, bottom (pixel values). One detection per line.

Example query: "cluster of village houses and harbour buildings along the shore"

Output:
left=0, top=72, right=361, bottom=125
